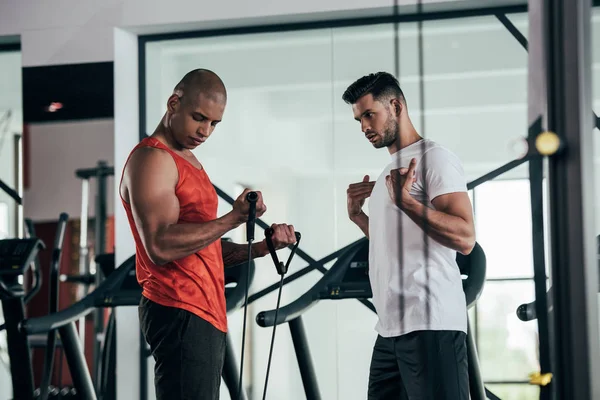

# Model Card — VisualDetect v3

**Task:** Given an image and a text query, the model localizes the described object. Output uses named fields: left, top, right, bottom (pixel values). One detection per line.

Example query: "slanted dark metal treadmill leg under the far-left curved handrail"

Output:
left=58, top=322, right=96, bottom=400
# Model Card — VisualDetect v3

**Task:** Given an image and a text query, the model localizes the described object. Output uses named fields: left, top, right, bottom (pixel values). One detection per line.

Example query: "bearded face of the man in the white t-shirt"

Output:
left=352, top=94, right=398, bottom=149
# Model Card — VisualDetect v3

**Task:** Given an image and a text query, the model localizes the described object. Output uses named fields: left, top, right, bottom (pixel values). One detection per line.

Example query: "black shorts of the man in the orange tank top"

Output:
left=139, top=296, right=226, bottom=400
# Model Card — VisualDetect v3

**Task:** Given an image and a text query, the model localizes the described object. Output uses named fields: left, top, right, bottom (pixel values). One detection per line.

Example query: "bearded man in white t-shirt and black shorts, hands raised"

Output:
left=343, top=72, right=475, bottom=400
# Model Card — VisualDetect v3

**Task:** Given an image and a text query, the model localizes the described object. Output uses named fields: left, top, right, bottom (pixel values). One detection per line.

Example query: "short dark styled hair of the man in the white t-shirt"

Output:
left=342, top=72, right=406, bottom=104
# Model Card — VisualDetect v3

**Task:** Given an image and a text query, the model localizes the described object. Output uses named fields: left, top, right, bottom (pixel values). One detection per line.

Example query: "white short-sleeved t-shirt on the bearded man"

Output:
left=368, top=139, right=467, bottom=337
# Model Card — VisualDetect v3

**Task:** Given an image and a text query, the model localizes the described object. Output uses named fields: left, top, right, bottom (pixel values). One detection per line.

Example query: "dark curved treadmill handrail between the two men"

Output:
left=256, top=238, right=366, bottom=328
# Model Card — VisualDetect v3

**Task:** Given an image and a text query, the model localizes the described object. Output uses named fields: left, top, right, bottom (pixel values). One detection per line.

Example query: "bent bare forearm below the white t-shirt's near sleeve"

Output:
left=403, top=192, right=475, bottom=255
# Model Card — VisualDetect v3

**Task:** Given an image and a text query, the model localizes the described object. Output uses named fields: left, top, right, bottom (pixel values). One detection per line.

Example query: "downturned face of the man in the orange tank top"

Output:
left=168, top=93, right=225, bottom=150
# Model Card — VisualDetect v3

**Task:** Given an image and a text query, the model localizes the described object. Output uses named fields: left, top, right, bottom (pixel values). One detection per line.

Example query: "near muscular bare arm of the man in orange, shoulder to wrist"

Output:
left=124, top=148, right=242, bottom=265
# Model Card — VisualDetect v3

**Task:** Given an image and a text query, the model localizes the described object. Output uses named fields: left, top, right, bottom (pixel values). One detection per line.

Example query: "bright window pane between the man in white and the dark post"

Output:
left=472, top=179, right=539, bottom=399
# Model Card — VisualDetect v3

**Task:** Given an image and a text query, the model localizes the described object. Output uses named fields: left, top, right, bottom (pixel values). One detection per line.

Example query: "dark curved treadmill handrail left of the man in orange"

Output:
left=19, top=256, right=135, bottom=335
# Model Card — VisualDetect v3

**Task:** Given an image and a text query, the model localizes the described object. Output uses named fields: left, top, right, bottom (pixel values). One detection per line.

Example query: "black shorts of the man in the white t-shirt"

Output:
left=368, top=331, right=469, bottom=400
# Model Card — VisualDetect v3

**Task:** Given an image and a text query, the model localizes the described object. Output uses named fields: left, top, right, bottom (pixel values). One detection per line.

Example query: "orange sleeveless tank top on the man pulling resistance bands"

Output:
left=121, top=137, right=227, bottom=332
